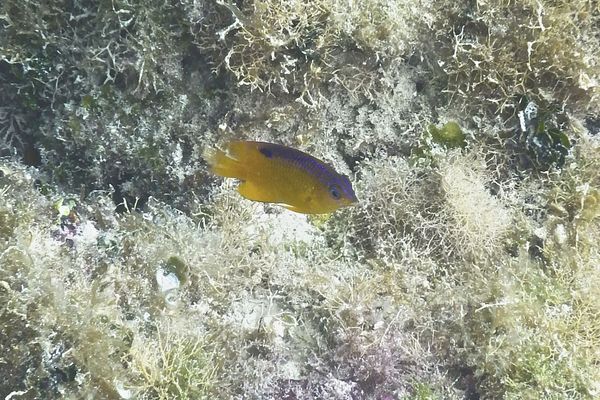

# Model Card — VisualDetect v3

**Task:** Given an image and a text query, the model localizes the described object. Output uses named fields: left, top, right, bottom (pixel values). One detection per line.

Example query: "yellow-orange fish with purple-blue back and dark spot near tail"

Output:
left=207, top=141, right=358, bottom=214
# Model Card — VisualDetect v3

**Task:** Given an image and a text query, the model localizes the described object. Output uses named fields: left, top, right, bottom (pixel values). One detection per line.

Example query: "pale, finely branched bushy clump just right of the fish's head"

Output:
left=346, top=153, right=511, bottom=259
